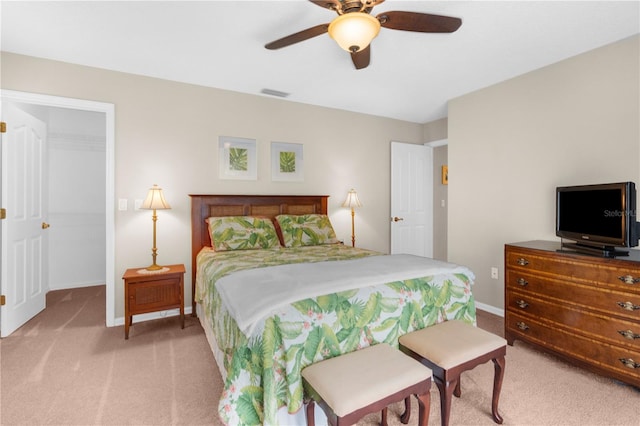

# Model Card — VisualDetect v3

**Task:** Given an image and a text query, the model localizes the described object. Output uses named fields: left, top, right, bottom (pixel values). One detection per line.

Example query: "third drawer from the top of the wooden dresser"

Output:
left=506, top=291, right=640, bottom=351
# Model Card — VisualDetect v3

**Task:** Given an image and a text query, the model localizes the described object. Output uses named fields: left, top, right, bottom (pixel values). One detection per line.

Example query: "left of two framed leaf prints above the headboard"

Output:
left=218, top=136, right=258, bottom=180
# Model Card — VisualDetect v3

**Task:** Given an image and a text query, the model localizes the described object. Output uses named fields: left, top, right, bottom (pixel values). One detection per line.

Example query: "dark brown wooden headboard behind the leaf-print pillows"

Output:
left=189, top=194, right=329, bottom=316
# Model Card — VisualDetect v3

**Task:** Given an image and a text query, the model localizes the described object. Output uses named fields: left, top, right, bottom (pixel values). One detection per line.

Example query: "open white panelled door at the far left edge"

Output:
left=0, top=102, right=48, bottom=337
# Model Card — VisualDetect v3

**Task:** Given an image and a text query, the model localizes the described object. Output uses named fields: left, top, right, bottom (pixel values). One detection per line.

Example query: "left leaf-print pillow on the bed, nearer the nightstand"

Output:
left=207, top=216, right=280, bottom=251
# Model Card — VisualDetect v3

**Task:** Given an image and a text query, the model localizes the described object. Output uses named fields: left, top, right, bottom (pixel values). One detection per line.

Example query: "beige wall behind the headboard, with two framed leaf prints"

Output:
left=1, top=53, right=423, bottom=318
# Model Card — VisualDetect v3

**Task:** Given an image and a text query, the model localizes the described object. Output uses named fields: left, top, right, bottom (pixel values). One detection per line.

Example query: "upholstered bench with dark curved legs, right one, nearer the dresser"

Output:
left=399, top=320, right=507, bottom=426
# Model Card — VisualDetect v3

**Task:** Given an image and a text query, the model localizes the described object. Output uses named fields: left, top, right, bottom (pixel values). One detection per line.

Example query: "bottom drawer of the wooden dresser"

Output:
left=505, top=311, right=640, bottom=386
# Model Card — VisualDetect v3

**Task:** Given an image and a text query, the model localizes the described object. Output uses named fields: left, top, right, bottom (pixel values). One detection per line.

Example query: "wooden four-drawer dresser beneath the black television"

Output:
left=505, top=241, right=640, bottom=387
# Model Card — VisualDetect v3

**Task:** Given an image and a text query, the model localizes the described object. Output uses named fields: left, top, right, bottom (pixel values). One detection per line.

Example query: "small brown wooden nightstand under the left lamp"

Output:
left=122, top=265, right=185, bottom=339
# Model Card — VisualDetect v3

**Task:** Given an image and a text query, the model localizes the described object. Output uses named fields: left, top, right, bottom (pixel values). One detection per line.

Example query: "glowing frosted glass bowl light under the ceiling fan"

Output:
left=328, top=12, right=380, bottom=53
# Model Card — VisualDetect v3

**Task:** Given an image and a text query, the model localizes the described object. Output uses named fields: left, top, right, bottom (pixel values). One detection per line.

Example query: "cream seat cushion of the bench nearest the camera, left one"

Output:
left=302, top=343, right=431, bottom=417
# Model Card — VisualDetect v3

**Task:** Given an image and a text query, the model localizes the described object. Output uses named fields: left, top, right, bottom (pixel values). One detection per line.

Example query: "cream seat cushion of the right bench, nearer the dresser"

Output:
left=399, top=320, right=507, bottom=369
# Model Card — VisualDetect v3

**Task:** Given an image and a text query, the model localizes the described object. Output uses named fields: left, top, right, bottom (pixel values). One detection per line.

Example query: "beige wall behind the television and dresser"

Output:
left=448, top=36, right=640, bottom=309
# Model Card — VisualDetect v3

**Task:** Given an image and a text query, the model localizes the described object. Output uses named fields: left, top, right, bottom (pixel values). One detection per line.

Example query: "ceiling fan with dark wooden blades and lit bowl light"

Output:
left=264, top=0, right=462, bottom=69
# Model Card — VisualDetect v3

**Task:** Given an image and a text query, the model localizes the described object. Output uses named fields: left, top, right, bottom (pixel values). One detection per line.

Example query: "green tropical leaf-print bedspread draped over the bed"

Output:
left=196, top=244, right=476, bottom=425
